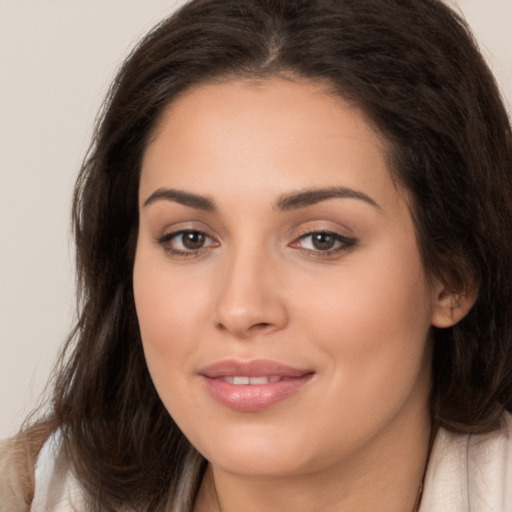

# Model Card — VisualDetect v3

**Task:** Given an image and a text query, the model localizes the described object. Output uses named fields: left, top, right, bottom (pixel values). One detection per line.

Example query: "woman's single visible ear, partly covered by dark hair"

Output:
left=432, top=282, right=477, bottom=329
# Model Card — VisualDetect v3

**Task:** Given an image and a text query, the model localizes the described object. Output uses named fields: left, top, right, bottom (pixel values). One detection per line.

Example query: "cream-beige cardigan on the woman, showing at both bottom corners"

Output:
left=0, top=414, right=512, bottom=512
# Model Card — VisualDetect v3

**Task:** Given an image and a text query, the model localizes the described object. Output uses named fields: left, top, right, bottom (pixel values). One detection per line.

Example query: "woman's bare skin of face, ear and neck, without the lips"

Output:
left=133, top=78, right=472, bottom=512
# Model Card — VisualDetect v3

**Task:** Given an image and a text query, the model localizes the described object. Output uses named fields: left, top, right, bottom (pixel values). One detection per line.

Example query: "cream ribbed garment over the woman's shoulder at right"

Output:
left=421, top=413, right=512, bottom=512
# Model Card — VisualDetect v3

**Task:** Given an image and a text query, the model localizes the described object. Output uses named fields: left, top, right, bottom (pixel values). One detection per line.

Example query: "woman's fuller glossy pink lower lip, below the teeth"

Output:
left=203, top=373, right=313, bottom=412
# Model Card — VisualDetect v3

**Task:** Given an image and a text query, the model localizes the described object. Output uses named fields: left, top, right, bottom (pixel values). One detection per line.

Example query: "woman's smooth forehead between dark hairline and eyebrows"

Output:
left=140, top=78, right=396, bottom=210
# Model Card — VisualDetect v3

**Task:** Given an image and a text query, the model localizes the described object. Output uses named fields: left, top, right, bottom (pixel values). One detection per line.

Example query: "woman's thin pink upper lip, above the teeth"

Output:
left=198, top=359, right=313, bottom=379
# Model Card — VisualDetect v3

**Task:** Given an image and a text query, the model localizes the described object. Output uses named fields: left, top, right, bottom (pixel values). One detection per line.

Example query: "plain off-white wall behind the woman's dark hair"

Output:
left=0, top=0, right=512, bottom=438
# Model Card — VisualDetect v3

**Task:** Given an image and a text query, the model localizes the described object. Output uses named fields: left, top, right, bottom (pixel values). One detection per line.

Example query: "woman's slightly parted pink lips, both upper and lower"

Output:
left=199, top=360, right=314, bottom=412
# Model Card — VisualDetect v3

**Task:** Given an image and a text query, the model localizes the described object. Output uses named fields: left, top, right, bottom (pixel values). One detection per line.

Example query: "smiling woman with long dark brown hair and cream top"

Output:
left=1, top=0, right=512, bottom=512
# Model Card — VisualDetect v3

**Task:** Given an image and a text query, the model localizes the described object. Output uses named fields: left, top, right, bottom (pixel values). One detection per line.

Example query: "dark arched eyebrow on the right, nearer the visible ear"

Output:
left=274, top=187, right=381, bottom=212
